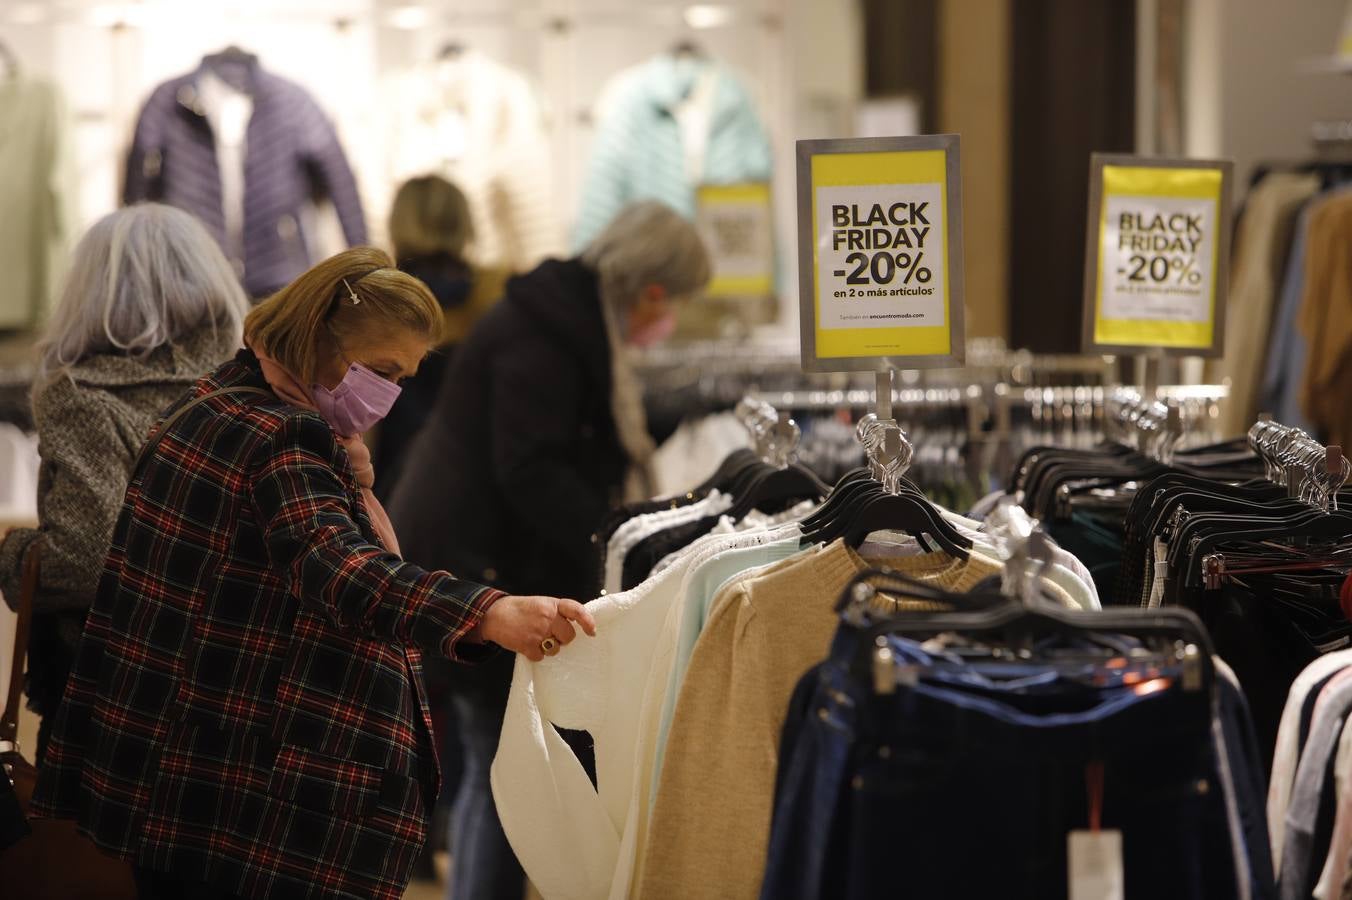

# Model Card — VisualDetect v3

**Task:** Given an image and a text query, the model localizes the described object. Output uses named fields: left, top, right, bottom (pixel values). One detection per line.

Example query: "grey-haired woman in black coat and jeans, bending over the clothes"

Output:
left=389, top=201, right=710, bottom=900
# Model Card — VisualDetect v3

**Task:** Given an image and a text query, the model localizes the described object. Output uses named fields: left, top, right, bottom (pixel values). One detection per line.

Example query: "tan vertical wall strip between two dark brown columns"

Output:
left=938, top=0, right=1010, bottom=336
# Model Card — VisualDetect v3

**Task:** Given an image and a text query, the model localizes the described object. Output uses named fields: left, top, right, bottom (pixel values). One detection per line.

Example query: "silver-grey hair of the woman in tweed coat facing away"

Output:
left=38, top=203, right=249, bottom=378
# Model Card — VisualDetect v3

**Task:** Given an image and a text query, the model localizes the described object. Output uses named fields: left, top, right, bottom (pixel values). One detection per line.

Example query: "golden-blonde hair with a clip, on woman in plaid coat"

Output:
left=245, top=247, right=442, bottom=384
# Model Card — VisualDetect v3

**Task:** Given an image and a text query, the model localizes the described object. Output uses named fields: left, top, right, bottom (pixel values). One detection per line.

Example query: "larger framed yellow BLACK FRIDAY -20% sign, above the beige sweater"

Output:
left=799, top=135, right=963, bottom=372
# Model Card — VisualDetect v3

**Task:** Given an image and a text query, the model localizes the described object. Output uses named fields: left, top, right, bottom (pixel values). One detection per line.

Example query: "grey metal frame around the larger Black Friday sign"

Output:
left=798, top=134, right=967, bottom=372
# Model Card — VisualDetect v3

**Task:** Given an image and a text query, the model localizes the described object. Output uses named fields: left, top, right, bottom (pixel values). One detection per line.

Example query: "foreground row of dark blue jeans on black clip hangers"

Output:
left=762, top=575, right=1274, bottom=900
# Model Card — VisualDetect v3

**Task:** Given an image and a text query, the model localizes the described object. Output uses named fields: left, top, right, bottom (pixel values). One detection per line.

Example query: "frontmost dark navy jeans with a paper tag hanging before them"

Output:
left=838, top=670, right=1238, bottom=900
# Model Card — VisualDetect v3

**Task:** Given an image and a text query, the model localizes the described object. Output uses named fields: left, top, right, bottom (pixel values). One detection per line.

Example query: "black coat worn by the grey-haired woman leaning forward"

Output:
left=389, top=259, right=629, bottom=600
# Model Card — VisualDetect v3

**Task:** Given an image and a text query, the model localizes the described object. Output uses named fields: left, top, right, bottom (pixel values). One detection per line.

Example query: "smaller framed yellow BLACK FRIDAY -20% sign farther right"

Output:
left=1086, top=157, right=1230, bottom=355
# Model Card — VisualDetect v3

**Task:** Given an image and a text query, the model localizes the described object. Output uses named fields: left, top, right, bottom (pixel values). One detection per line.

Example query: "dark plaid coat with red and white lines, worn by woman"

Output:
left=34, top=350, right=500, bottom=900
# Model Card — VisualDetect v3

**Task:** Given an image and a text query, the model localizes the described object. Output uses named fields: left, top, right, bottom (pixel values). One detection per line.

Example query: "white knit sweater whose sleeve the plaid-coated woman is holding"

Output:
left=491, top=526, right=796, bottom=900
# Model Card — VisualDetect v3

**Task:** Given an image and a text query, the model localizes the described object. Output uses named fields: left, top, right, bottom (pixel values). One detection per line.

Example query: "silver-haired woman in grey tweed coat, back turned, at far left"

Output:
left=0, top=204, right=249, bottom=765
